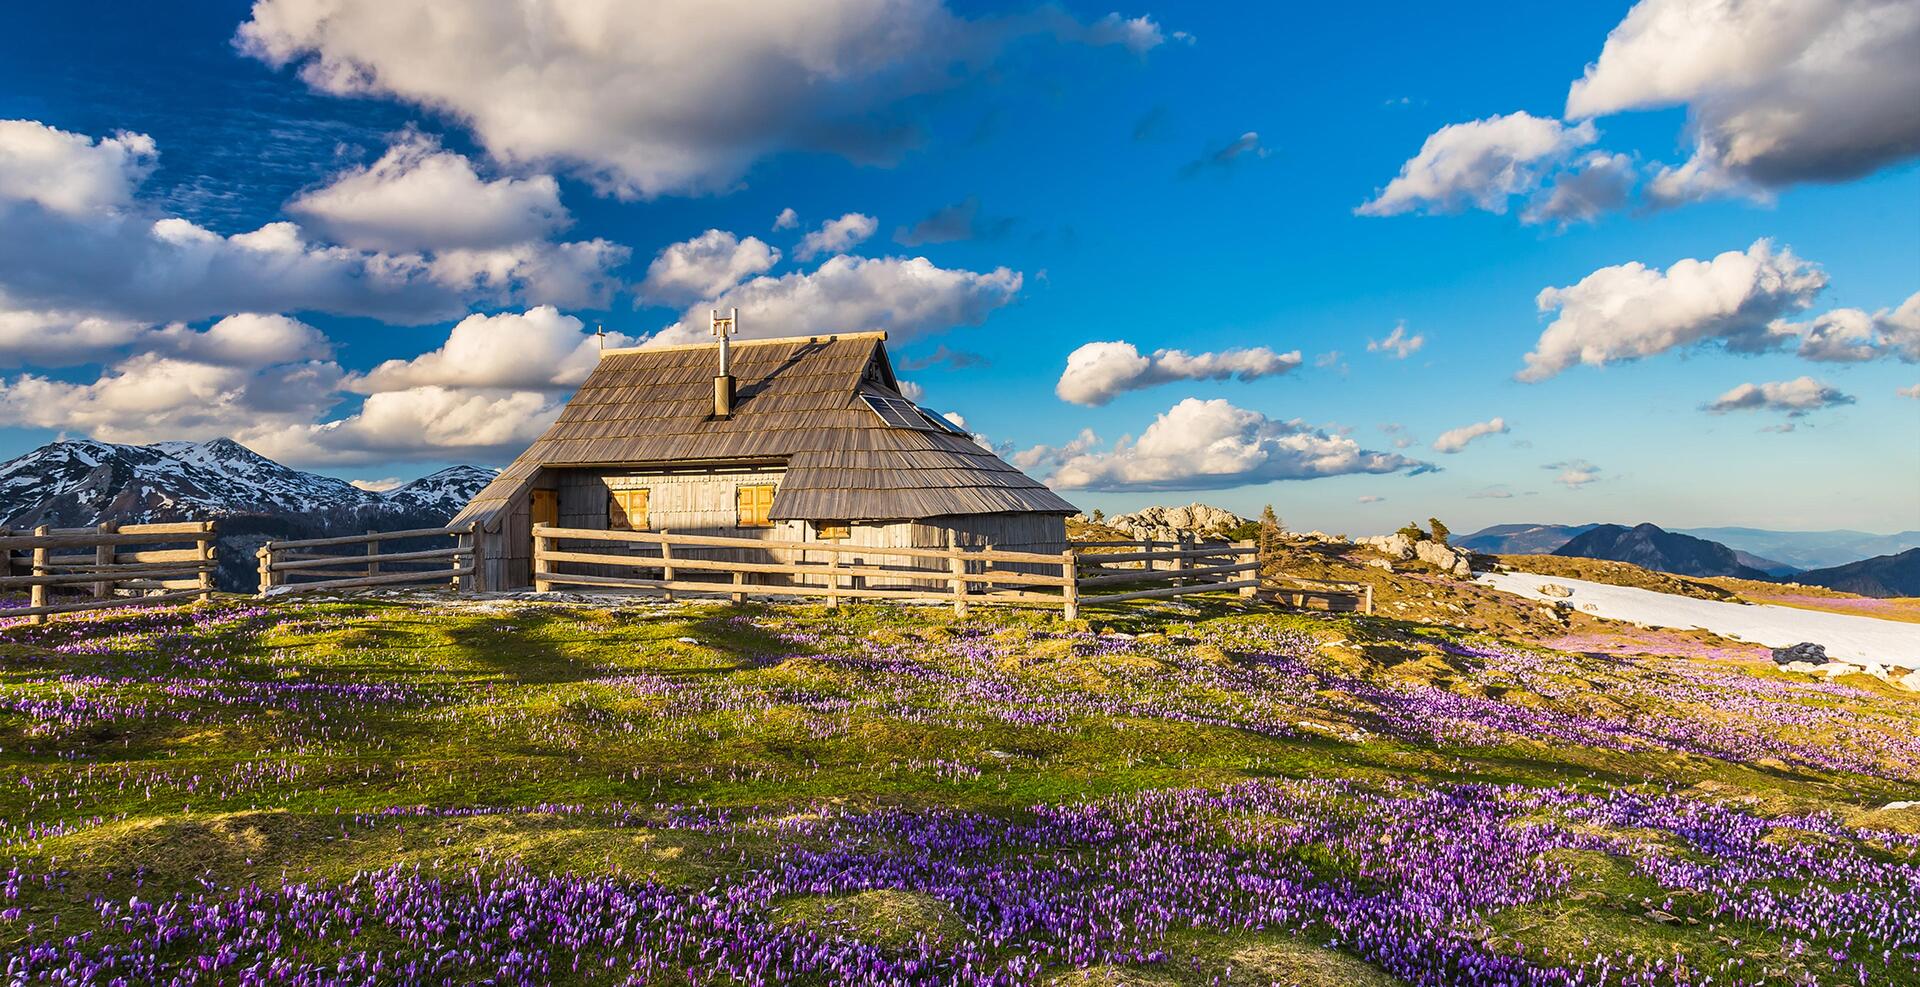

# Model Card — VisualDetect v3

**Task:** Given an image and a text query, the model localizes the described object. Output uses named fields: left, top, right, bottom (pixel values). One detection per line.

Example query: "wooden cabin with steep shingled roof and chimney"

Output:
left=453, top=319, right=1075, bottom=590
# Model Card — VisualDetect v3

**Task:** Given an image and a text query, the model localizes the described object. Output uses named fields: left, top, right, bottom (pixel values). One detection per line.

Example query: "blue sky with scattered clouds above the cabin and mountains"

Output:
left=0, top=0, right=1920, bottom=534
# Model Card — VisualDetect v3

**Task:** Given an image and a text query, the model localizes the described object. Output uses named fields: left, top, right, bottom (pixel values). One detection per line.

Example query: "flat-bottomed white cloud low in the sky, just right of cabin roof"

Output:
left=1048, top=397, right=1430, bottom=490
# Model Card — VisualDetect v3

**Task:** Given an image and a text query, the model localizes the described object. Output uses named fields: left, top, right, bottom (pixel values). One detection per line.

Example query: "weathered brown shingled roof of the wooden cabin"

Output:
left=455, top=332, right=1075, bottom=528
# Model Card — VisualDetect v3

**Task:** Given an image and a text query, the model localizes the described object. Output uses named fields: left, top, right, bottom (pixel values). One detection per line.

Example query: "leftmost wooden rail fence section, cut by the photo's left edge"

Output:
left=0, top=520, right=213, bottom=624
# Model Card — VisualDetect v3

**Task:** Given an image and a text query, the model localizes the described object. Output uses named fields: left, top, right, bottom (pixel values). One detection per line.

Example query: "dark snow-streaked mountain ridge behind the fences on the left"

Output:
left=0, top=438, right=493, bottom=590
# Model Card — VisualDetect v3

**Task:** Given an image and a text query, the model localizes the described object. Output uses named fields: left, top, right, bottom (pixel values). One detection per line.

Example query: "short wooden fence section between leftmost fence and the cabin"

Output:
left=255, top=524, right=474, bottom=597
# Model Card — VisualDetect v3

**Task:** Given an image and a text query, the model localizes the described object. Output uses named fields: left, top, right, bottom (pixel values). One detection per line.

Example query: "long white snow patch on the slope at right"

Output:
left=1476, top=572, right=1920, bottom=666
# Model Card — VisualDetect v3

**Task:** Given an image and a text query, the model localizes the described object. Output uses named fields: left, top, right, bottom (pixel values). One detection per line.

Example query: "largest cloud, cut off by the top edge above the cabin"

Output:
left=238, top=0, right=1162, bottom=196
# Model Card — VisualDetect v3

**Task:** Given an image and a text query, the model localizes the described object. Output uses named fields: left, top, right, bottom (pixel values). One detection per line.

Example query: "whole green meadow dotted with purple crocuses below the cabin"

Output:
left=0, top=587, right=1920, bottom=985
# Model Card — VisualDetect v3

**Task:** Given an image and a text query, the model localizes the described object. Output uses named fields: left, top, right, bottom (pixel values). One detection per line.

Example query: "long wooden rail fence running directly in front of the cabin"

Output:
left=534, top=524, right=1260, bottom=620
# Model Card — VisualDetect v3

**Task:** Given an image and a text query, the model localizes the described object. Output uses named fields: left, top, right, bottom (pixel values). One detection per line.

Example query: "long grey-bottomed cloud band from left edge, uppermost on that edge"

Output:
left=0, top=123, right=626, bottom=326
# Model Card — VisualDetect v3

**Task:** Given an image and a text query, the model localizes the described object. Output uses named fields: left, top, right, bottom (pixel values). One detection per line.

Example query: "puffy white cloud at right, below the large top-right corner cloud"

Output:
left=1519, top=240, right=1826, bottom=380
